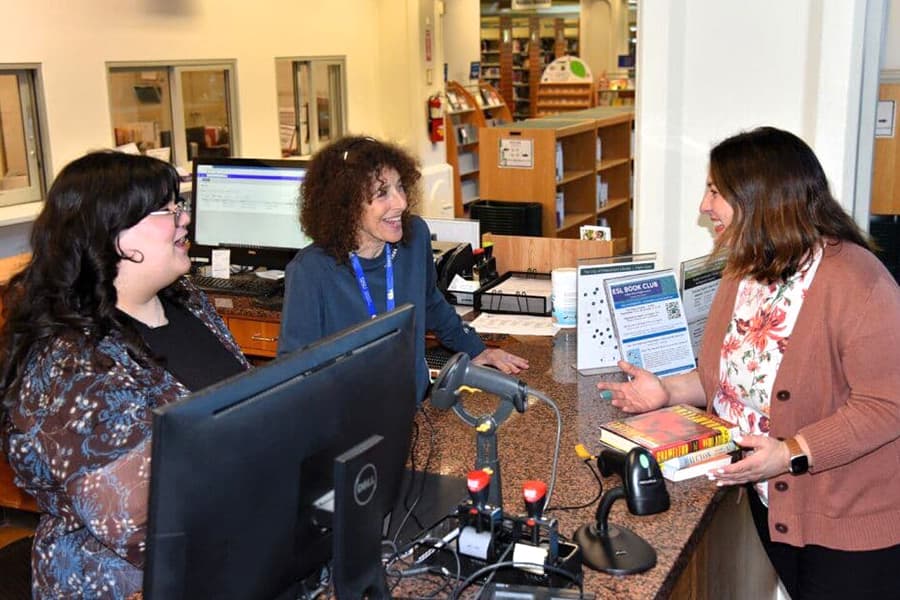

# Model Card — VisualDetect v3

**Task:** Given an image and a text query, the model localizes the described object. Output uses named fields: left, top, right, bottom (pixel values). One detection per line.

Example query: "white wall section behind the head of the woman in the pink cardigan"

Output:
left=635, top=0, right=868, bottom=267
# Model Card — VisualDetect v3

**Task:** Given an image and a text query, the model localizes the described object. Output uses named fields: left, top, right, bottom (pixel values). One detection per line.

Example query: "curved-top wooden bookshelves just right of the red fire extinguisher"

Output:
left=444, top=81, right=512, bottom=217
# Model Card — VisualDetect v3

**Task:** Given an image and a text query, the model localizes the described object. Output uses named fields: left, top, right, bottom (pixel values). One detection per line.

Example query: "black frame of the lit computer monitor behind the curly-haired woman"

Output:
left=188, top=156, right=309, bottom=270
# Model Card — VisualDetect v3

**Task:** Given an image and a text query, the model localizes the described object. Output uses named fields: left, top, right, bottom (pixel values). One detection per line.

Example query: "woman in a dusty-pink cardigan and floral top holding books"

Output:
left=597, top=127, right=900, bottom=600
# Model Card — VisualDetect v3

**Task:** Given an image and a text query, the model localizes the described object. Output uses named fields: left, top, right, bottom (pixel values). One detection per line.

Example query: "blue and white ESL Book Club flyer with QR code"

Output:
left=604, top=269, right=695, bottom=377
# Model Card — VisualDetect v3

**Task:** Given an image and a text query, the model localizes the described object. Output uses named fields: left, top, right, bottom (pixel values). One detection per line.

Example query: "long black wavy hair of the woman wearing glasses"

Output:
left=0, top=151, right=186, bottom=406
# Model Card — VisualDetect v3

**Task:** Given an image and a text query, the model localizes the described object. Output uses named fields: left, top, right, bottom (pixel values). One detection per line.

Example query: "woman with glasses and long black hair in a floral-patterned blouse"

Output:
left=0, top=152, right=248, bottom=598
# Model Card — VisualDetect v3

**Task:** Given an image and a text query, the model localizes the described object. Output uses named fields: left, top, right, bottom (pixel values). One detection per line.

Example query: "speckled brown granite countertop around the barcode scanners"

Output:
left=396, top=330, right=725, bottom=600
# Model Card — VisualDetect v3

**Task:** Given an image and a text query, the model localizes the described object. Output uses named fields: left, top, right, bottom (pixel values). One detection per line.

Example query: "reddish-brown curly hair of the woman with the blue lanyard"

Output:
left=300, top=136, right=422, bottom=263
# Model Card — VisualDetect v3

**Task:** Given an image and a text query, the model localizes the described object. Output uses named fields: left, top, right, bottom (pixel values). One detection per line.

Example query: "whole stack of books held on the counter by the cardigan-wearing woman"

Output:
left=600, top=404, right=740, bottom=481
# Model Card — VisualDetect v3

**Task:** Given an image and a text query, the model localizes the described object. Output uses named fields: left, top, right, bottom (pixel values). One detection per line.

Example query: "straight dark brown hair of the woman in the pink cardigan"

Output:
left=709, top=127, right=872, bottom=283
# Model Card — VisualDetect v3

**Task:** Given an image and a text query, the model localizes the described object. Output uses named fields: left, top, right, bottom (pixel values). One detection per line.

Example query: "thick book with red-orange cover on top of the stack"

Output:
left=600, top=404, right=739, bottom=464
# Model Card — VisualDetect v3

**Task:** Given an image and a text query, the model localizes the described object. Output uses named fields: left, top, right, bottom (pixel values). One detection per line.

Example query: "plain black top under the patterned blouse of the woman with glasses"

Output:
left=131, top=300, right=244, bottom=392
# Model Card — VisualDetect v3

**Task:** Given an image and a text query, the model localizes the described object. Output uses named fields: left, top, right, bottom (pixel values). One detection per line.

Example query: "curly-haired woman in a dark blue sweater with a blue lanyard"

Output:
left=278, top=137, right=528, bottom=401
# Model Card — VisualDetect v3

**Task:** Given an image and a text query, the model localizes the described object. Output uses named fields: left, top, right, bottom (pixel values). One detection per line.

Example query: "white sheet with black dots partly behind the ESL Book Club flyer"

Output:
left=575, top=253, right=656, bottom=375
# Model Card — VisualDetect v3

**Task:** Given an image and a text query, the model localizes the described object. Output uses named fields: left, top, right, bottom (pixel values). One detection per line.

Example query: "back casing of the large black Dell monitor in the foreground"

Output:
left=144, top=304, right=417, bottom=600
